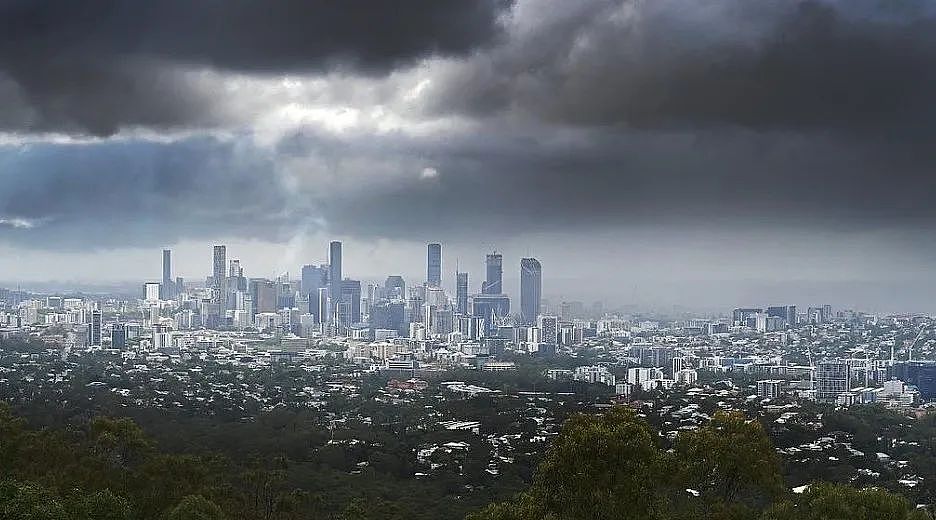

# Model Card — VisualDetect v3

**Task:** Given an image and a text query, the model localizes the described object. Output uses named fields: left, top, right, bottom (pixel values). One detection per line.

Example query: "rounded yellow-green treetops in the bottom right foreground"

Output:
left=468, top=408, right=932, bottom=520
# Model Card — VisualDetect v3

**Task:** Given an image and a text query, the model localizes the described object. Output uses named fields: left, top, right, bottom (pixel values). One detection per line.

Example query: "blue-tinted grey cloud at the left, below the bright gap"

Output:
left=0, top=138, right=308, bottom=250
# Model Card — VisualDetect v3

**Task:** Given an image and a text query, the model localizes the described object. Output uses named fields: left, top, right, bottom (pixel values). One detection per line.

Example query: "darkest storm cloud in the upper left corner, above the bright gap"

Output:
left=0, top=0, right=508, bottom=135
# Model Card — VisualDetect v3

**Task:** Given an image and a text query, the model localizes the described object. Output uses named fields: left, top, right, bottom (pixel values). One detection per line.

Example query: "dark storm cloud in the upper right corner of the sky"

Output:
left=431, top=0, right=936, bottom=137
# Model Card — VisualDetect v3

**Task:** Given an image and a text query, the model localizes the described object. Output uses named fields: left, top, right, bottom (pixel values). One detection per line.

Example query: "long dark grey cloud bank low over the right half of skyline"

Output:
left=281, top=125, right=936, bottom=238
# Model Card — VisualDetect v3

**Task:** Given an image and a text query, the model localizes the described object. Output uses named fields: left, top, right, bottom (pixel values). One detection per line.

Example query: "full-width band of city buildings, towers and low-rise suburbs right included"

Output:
left=0, top=274, right=936, bottom=416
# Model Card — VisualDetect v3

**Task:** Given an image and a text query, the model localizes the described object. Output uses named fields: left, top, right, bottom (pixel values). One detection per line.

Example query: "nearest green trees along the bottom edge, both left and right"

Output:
left=0, top=405, right=932, bottom=520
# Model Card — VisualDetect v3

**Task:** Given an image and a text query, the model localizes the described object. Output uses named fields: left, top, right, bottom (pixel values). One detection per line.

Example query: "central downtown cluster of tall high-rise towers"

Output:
left=143, top=241, right=560, bottom=345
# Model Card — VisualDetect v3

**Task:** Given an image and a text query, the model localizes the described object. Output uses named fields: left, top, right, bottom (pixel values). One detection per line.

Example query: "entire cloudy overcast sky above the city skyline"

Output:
left=0, top=0, right=936, bottom=312
